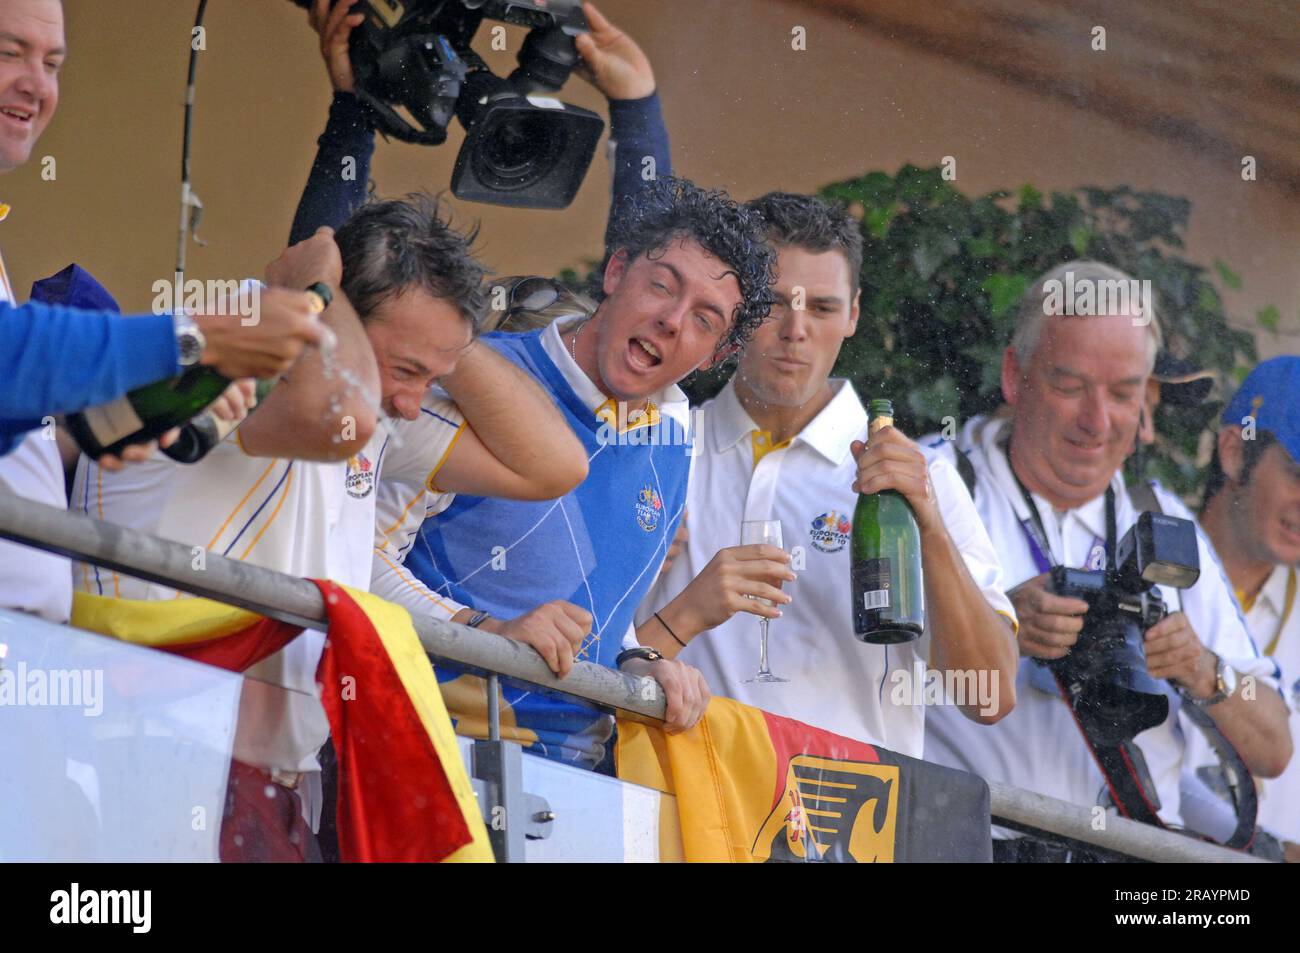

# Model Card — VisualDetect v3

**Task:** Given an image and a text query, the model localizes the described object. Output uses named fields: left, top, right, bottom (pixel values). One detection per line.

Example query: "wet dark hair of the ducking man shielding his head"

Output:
left=334, top=192, right=488, bottom=333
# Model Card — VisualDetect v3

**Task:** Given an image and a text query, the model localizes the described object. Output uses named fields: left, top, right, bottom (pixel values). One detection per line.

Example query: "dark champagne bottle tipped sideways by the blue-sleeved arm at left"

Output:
left=64, top=282, right=333, bottom=463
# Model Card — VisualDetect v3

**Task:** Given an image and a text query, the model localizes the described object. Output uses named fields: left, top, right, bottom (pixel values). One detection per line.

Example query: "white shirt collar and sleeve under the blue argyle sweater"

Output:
left=371, top=315, right=694, bottom=647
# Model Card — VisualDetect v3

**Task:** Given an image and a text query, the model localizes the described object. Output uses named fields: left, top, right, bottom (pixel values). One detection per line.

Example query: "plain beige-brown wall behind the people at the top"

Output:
left=0, top=0, right=1300, bottom=354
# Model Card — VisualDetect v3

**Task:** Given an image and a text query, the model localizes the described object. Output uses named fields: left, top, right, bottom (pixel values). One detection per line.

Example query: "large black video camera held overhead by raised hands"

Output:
left=293, top=0, right=605, bottom=208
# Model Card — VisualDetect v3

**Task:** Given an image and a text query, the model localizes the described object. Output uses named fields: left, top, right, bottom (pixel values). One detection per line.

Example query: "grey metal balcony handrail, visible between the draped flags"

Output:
left=0, top=494, right=1261, bottom=863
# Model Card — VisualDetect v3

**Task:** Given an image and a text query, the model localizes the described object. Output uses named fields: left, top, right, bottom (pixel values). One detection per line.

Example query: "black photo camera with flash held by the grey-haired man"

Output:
left=1040, top=512, right=1200, bottom=744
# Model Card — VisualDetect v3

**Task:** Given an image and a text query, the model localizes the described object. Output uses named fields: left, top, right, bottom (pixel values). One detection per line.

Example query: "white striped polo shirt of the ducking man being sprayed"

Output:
left=73, top=390, right=463, bottom=772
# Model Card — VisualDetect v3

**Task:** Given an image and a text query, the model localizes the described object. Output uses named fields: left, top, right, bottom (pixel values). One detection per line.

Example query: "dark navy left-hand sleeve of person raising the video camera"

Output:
left=289, top=92, right=374, bottom=244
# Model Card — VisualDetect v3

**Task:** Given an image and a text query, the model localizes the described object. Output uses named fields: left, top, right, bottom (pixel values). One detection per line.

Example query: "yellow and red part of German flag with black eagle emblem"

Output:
left=616, top=698, right=901, bottom=863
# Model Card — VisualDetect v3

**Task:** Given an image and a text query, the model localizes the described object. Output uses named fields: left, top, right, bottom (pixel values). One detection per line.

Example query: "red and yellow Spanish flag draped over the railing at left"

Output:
left=72, top=580, right=493, bottom=862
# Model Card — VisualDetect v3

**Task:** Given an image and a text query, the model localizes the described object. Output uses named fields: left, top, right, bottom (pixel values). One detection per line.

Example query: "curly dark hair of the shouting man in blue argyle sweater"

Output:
left=603, top=177, right=776, bottom=351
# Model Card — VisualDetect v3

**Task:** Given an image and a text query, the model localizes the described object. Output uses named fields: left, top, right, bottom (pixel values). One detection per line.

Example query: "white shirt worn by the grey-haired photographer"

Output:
left=926, top=417, right=1277, bottom=824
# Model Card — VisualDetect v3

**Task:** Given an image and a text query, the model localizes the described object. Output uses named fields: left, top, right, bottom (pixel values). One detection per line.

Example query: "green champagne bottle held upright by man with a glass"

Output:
left=849, top=400, right=926, bottom=645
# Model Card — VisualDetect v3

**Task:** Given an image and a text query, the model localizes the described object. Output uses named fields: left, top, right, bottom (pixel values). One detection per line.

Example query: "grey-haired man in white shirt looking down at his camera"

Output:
left=923, top=261, right=1291, bottom=861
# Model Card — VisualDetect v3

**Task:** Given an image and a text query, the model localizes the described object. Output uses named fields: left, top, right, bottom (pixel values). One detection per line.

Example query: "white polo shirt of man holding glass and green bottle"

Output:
left=637, top=381, right=1014, bottom=758
